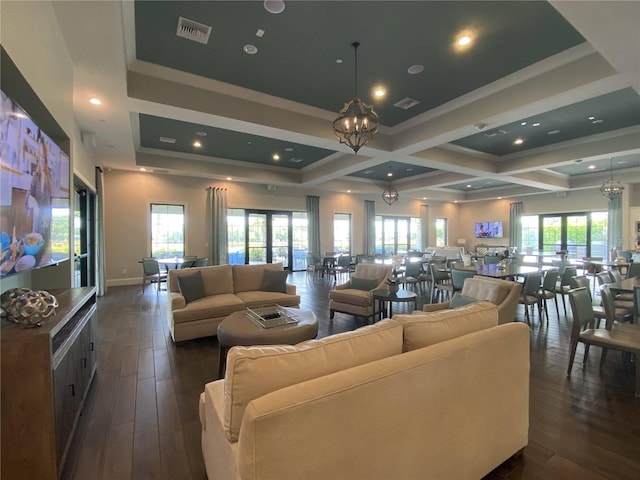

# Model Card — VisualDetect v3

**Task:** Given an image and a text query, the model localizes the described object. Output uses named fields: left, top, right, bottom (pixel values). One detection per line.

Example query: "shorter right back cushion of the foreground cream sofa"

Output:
left=393, top=301, right=498, bottom=352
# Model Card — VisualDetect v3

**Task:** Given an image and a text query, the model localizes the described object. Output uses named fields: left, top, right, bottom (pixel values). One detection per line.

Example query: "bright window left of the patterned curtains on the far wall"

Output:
left=151, top=203, right=185, bottom=258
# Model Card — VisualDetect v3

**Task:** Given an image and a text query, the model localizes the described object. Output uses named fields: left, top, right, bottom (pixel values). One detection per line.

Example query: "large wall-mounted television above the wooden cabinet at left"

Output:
left=0, top=90, right=70, bottom=277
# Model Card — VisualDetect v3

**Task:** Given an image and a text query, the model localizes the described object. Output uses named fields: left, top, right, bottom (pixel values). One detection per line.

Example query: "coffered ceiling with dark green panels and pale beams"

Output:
left=54, top=0, right=640, bottom=201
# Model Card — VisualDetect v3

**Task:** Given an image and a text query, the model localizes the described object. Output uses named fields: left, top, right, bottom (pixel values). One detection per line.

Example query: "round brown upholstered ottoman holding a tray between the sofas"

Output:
left=218, top=309, right=318, bottom=378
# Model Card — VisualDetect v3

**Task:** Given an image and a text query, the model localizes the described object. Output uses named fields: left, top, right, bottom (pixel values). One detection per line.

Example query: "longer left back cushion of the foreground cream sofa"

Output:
left=224, top=319, right=402, bottom=442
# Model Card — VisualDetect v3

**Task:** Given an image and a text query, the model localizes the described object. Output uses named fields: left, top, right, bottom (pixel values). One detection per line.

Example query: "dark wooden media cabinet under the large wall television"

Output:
left=0, top=287, right=97, bottom=480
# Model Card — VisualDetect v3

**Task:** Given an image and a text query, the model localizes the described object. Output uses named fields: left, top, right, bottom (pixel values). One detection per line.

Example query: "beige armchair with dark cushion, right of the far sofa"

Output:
left=329, top=263, right=393, bottom=320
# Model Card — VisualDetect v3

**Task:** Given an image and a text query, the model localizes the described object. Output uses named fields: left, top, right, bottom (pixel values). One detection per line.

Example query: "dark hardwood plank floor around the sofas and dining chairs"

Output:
left=63, top=272, right=640, bottom=480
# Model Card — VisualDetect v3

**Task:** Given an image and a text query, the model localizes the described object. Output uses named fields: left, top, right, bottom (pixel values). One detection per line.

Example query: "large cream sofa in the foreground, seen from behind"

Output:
left=200, top=302, right=529, bottom=480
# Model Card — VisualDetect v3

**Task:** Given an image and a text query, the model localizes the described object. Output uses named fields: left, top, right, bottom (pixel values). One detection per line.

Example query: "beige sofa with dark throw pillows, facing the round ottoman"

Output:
left=167, top=263, right=300, bottom=342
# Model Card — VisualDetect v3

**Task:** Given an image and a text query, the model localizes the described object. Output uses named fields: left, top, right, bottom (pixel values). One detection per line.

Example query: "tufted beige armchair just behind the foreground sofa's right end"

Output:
left=422, top=275, right=522, bottom=325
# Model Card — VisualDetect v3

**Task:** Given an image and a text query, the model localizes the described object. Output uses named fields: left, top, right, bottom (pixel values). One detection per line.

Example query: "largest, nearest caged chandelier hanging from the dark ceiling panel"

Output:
left=333, top=42, right=380, bottom=153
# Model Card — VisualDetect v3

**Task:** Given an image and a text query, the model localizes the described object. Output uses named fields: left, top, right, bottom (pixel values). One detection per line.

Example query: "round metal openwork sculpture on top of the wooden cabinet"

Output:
left=0, top=287, right=58, bottom=328
